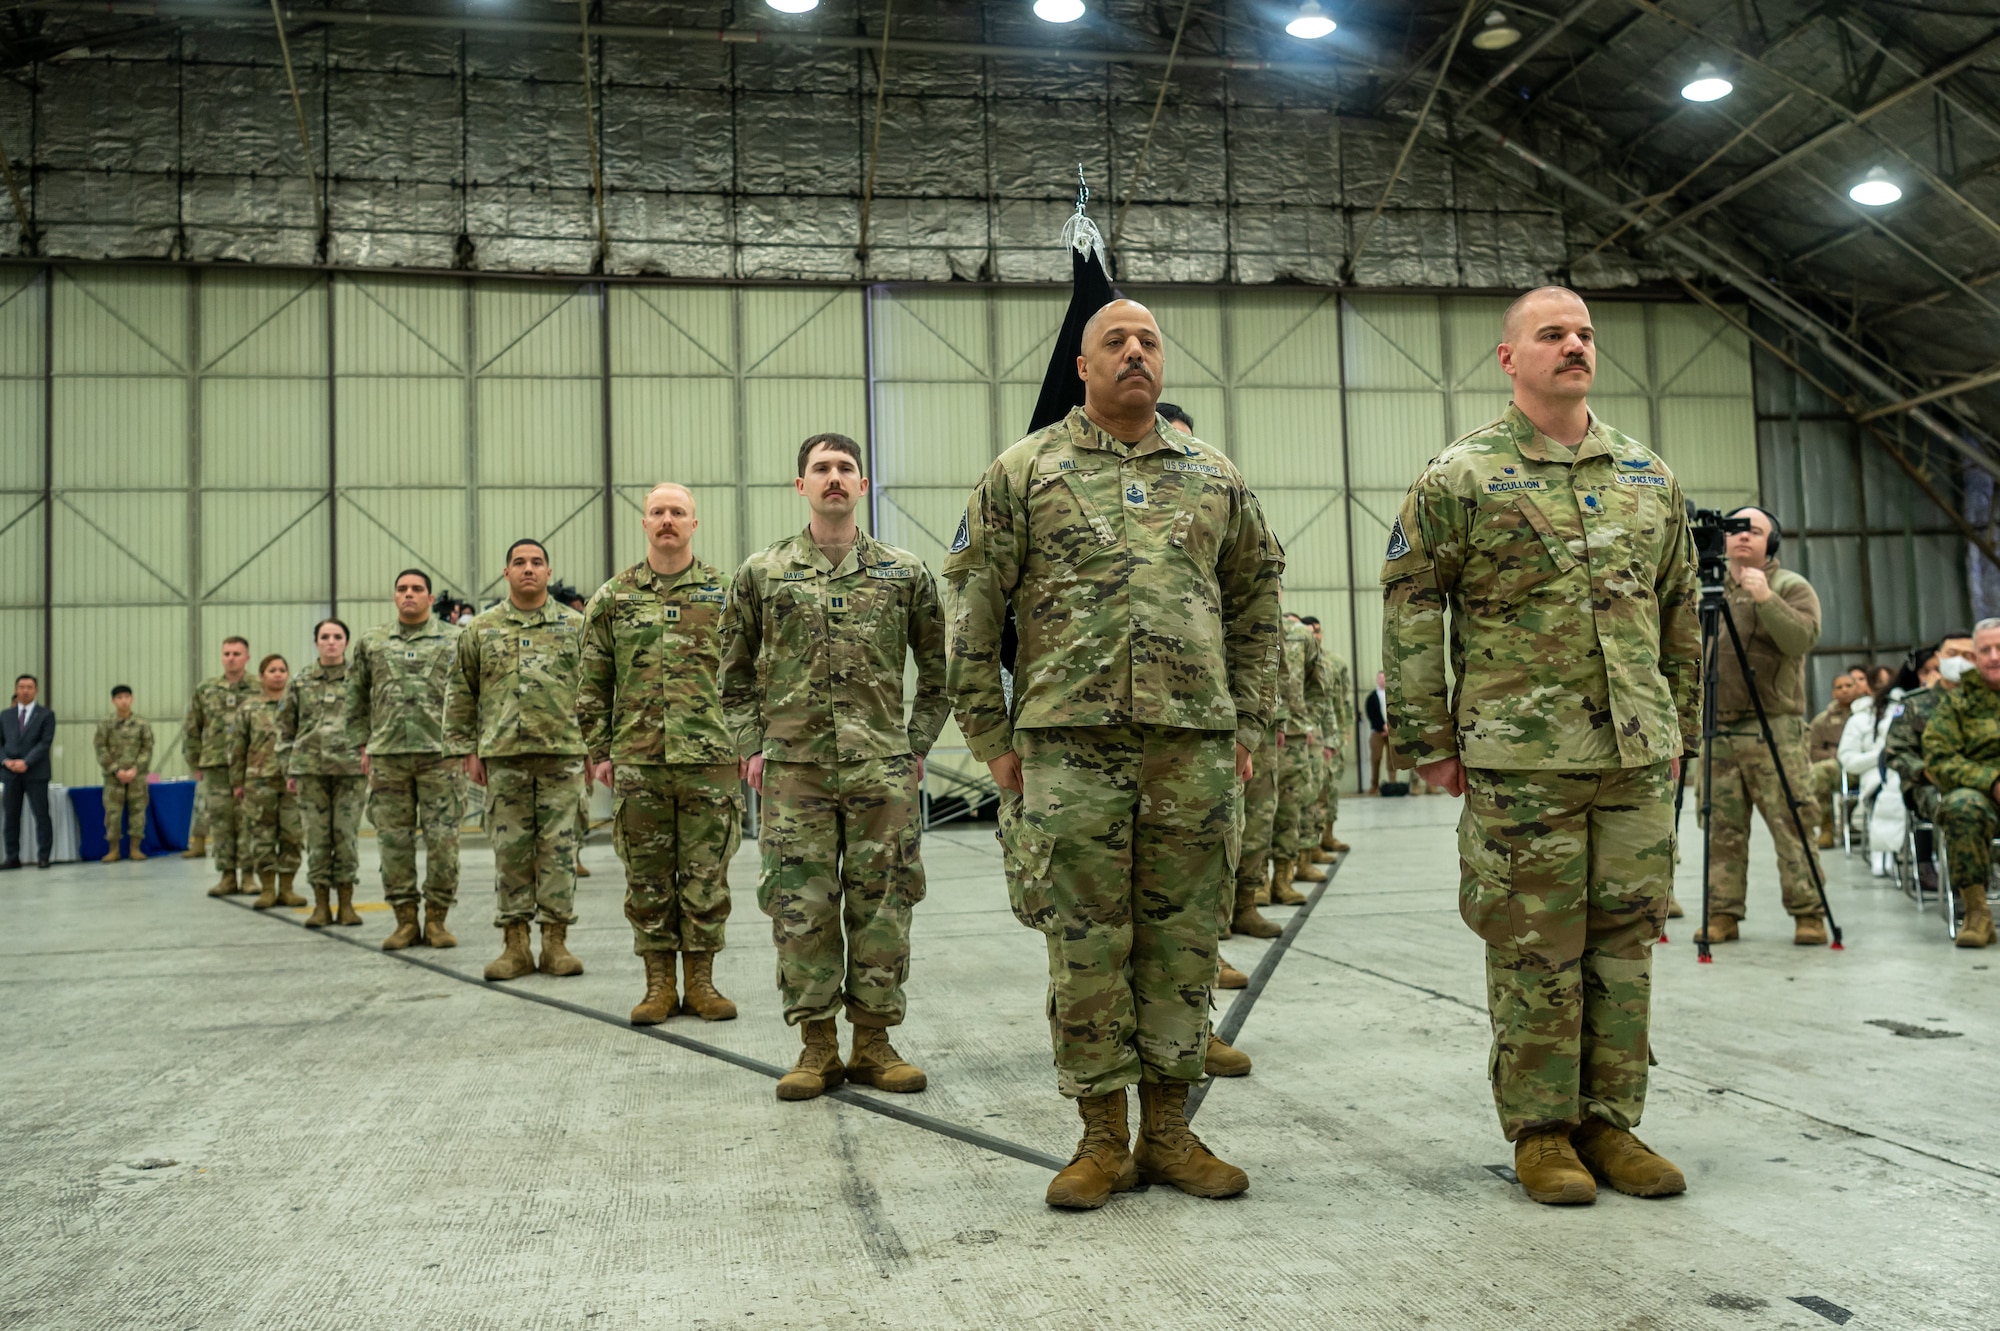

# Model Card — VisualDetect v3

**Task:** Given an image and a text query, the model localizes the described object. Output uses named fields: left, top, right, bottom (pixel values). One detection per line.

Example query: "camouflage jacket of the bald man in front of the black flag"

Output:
left=944, top=408, right=1284, bottom=761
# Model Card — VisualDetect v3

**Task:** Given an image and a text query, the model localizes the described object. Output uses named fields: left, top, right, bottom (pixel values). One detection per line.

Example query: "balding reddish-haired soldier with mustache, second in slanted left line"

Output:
left=576, top=484, right=744, bottom=1025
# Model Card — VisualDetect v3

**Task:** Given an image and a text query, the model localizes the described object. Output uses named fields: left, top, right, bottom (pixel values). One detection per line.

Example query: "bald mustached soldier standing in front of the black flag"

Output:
left=944, top=300, right=1284, bottom=1209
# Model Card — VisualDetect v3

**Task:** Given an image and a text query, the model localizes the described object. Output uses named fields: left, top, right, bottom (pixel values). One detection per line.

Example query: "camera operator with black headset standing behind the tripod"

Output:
left=1696, top=508, right=1826, bottom=947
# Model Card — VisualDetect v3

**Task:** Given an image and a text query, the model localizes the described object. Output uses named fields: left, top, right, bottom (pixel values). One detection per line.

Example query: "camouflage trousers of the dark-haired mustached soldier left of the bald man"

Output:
left=756, top=753, right=924, bottom=1027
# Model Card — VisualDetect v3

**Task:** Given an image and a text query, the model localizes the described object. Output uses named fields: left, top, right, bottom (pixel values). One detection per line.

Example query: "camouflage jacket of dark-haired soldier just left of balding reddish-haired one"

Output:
left=444, top=598, right=584, bottom=757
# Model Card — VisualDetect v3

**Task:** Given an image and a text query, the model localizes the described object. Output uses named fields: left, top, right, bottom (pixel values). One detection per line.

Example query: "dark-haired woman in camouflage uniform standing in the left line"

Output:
left=278, top=620, right=368, bottom=929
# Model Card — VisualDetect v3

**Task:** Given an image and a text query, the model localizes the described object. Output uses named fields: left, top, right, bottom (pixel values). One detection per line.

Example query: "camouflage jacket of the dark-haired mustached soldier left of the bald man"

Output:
left=722, top=528, right=950, bottom=763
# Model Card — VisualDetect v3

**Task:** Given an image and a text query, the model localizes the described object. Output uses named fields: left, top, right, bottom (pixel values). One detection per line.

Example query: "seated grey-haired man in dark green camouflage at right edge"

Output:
left=1924, top=620, right=2000, bottom=947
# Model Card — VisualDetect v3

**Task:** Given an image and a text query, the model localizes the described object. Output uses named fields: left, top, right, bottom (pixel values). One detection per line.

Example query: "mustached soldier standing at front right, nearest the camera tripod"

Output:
left=1382, top=286, right=1702, bottom=1203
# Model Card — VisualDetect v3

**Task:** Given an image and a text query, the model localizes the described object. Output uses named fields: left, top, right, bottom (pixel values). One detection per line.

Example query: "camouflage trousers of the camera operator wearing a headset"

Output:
left=1696, top=715, right=1820, bottom=919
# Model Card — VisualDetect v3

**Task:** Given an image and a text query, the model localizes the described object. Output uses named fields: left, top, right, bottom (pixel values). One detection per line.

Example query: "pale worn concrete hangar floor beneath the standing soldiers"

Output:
left=0, top=797, right=2000, bottom=1331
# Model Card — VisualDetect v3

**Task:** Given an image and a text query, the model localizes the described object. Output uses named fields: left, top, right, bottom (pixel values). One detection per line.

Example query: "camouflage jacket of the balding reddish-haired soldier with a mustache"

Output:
left=576, top=560, right=736, bottom=763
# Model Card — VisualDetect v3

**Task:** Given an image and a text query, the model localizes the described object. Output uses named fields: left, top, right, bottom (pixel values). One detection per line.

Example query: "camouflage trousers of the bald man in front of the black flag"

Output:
left=1002, top=725, right=1254, bottom=1097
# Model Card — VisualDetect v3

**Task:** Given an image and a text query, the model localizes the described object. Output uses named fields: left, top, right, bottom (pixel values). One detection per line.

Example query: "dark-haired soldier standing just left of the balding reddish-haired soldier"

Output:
left=444, top=540, right=584, bottom=979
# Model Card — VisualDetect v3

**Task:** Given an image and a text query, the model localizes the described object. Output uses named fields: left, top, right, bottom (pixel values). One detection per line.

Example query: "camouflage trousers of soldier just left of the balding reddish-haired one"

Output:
left=484, top=753, right=584, bottom=927
